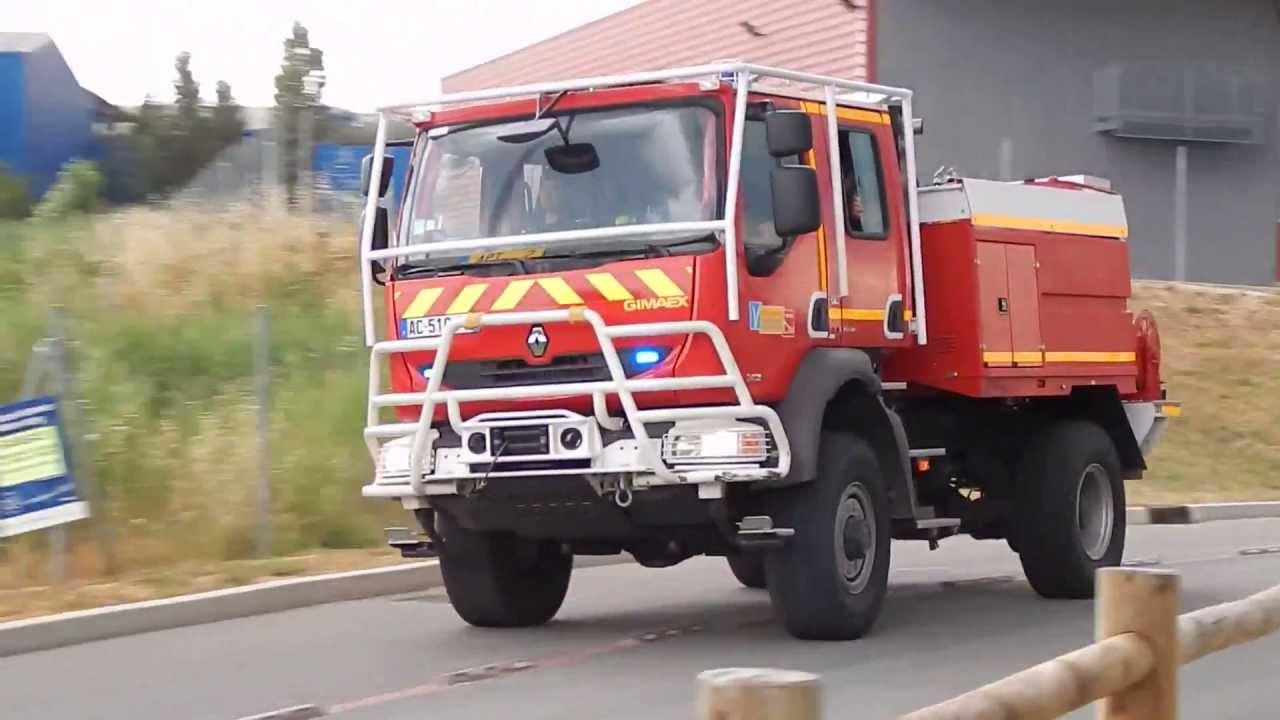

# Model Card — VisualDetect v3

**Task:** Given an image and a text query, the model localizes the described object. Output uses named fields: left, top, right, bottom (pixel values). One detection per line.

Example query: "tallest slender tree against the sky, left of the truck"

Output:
left=275, top=22, right=324, bottom=205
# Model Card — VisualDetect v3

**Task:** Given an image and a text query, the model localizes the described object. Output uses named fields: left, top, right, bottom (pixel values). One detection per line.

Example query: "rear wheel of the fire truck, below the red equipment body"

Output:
left=1016, top=420, right=1125, bottom=600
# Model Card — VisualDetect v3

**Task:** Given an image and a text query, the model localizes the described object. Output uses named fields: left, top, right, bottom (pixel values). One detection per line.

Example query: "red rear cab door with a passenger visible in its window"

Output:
left=823, top=108, right=911, bottom=347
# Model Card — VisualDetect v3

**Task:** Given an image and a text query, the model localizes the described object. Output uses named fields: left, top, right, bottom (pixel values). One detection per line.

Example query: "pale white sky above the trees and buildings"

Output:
left=0, top=0, right=637, bottom=111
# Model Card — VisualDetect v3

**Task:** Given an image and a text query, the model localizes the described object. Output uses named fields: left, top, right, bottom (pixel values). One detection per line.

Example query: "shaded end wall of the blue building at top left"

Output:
left=22, top=42, right=93, bottom=196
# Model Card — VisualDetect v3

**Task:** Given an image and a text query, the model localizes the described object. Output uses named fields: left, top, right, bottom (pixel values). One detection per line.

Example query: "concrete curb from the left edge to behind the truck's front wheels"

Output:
left=0, top=556, right=631, bottom=657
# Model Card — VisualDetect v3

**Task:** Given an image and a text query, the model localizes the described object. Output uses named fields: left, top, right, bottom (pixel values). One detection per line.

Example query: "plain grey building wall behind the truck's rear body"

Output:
left=873, top=0, right=1280, bottom=283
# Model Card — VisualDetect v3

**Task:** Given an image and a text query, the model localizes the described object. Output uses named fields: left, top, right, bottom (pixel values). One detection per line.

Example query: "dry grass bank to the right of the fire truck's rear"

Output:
left=1129, top=278, right=1280, bottom=503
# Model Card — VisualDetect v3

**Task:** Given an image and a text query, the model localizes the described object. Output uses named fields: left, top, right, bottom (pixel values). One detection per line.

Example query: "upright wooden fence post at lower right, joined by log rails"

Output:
left=1096, top=568, right=1179, bottom=720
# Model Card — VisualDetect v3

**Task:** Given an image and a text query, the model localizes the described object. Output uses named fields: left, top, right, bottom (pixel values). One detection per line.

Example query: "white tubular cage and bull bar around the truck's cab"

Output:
left=360, top=61, right=928, bottom=496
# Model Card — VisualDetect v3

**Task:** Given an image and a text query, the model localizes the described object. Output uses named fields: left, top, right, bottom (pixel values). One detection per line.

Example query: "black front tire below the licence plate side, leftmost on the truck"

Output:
left=440, top=515, right=573, bottom=628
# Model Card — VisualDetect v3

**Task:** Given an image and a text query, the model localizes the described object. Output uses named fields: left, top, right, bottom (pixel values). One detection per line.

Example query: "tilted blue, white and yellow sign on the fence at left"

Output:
left=0, top=397, right=88, bottom=537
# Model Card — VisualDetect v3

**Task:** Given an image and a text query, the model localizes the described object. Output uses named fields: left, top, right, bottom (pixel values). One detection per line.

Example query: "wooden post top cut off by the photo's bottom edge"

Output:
left=698, top=667, right=819, bottom=720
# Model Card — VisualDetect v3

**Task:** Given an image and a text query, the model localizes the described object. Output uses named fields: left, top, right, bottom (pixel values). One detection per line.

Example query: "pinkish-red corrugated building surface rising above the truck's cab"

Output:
left=443, top=0, right=868, bottom=92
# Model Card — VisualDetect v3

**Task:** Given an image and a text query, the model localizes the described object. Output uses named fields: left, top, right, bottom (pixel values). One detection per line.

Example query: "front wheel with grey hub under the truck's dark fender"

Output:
left=764, top=432, right=891, bottom=641
